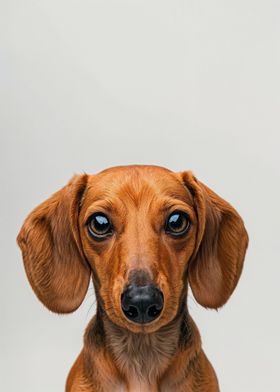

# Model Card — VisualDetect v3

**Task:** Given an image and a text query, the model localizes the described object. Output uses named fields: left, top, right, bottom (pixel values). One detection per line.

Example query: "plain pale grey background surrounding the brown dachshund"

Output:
left=0, top=0, right=280, bottom=392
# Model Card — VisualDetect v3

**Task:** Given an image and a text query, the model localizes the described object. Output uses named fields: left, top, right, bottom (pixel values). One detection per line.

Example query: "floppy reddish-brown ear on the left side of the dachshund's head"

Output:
left=17, top=174, right=90, bottom=313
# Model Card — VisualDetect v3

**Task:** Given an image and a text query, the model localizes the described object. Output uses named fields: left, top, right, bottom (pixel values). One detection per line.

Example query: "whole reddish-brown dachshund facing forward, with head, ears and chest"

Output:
left=18, top=166, right=248, bottom=392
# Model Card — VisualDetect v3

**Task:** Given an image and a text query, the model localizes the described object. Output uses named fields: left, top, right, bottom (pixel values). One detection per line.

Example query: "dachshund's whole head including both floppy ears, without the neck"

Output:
left=18, top=166, right=248, bottom=332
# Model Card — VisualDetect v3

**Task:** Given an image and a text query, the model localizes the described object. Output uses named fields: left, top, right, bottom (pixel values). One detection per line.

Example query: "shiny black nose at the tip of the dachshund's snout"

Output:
left=121, top=284, right=163, bottom=324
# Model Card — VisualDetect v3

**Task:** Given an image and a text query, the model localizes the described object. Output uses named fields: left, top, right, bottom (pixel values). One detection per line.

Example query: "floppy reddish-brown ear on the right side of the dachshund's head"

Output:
left=182, top=172, right=248, bottom=309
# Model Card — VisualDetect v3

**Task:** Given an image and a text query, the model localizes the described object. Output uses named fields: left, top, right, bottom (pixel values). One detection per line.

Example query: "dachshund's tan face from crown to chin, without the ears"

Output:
left=79, top=168, right=197, bottom=331
